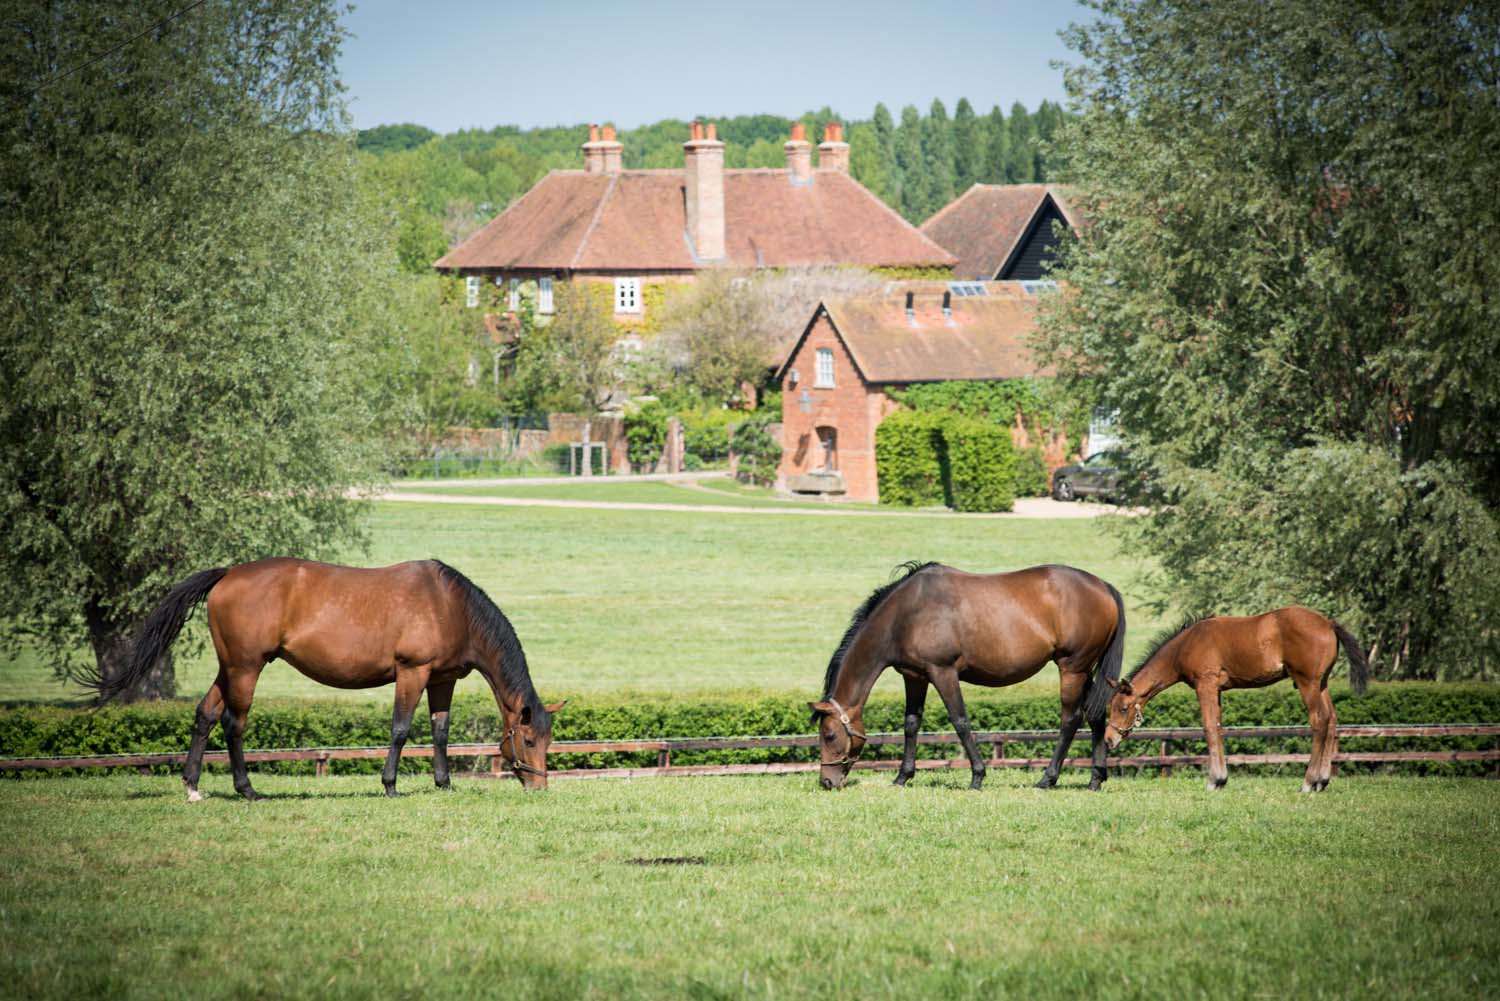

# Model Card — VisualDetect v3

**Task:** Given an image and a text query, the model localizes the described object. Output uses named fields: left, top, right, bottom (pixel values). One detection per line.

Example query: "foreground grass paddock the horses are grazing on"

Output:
left=0, top=771, right=1500, bottom=1001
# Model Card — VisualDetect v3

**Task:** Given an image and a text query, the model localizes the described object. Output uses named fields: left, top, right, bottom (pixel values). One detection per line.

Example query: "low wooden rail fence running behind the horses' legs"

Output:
left=0, top=723, right=1500, bottom=779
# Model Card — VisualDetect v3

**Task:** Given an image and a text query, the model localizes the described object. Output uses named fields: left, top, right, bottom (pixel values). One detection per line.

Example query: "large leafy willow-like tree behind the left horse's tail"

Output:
left=0, top=0, right=393, bottom=696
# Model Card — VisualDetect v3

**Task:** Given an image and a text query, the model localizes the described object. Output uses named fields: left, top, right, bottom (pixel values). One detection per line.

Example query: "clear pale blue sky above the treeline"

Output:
left=341, top=0, right=1089, bottom=132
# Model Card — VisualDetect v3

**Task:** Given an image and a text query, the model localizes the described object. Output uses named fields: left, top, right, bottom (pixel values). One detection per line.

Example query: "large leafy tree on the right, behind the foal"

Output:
left=1043, top=0, right=1500, bottom=677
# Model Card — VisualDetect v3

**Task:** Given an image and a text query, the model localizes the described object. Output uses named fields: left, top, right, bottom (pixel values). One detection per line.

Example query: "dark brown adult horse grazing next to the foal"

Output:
left=809, top=563, right=1125, bottom=789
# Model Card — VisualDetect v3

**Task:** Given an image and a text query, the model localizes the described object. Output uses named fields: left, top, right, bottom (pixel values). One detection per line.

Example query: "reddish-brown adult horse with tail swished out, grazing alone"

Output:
left=98, top=558, right=563, bottom=801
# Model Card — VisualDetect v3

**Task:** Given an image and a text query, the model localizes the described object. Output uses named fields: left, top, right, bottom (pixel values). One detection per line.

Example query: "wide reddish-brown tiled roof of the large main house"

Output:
left=434, top=170, right=954, bottom=272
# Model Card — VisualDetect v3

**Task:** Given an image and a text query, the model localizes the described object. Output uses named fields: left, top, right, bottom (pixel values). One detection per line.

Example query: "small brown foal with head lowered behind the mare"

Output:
left=1106, top=606, right=1370, bottom=792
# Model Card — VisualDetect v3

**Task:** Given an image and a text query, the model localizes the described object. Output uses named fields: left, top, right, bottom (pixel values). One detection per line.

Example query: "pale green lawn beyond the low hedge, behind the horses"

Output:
left=0, top=501, right=1163, bottom=701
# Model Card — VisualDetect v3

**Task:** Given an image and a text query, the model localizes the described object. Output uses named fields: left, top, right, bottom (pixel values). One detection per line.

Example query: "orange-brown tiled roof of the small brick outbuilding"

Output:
left=777, top=282, right=1052, bottom=384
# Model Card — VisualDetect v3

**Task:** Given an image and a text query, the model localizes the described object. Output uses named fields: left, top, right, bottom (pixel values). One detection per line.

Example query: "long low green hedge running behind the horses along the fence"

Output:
left=0, top=683, right=1500, bottom=774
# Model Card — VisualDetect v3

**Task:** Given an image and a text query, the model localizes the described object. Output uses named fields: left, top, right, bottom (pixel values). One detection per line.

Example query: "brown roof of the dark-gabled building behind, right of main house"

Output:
left=923, top=185, right=1079, bottom=281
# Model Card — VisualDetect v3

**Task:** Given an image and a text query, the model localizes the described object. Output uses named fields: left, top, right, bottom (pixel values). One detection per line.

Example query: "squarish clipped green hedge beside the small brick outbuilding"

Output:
left=875, top=410, right=1035, bottom=512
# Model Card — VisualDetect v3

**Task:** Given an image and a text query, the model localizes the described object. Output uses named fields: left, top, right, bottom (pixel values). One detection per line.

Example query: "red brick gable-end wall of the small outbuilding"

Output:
left=777, top=314, right=896, bottom=501
